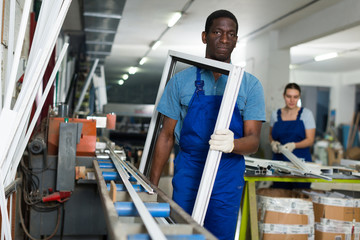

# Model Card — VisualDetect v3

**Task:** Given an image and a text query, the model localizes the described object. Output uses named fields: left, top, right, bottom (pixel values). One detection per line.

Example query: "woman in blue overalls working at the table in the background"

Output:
left=269, top=83, right=315, bottom=188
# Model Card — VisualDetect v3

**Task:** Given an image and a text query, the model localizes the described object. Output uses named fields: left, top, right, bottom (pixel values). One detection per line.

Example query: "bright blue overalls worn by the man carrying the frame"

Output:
left=173, top=68, right=245, bottom=239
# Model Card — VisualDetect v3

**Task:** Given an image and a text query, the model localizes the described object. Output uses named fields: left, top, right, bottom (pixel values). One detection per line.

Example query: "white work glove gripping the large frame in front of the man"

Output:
left=209, top=129, right=234, bottom=153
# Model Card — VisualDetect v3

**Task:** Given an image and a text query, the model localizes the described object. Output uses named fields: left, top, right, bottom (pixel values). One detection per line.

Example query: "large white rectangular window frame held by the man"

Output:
left=139, top=51, right=244, bottom=225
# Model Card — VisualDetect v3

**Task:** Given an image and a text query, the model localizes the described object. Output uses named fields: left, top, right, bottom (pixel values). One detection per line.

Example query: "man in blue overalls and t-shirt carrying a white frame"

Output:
left=150, top=10, right=265, bottom=239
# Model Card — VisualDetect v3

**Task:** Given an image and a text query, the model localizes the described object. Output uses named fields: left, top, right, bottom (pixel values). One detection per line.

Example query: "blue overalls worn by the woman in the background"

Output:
left=271, top=108, right=312, bottom=189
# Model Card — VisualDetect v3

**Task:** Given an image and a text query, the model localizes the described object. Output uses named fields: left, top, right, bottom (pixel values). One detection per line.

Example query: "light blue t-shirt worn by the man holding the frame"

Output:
left=157, top=67, right=265, bottom=142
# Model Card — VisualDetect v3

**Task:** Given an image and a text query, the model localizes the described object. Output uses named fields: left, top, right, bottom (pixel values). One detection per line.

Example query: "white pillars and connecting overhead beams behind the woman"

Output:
left=246, top=0, right=360, bottom=131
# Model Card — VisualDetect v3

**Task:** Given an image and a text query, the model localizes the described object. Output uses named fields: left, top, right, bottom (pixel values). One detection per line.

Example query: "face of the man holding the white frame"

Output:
left=202, top=18, right=238, bottom=63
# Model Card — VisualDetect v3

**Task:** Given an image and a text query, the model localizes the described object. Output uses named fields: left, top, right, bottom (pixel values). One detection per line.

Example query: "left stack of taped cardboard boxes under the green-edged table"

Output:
left=257, top=189, right=314, bottom=240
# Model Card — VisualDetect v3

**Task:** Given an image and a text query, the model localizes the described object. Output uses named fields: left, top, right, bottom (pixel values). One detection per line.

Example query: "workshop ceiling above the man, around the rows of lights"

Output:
left=64, top=0, right=360, bottom=101
